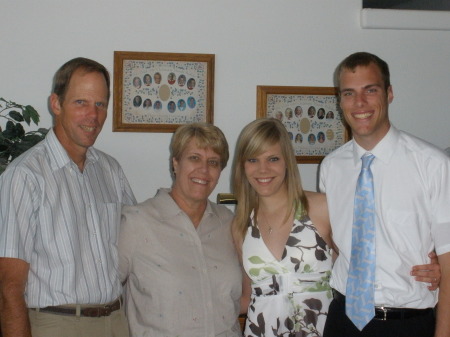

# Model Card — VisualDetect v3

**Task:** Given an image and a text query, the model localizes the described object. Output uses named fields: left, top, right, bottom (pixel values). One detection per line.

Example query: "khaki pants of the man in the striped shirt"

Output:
left=28, top=307, right=129, bottom=337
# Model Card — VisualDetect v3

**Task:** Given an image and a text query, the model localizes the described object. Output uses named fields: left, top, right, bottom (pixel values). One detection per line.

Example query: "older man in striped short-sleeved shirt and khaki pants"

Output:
left=0, top=58, right=136, bottom=337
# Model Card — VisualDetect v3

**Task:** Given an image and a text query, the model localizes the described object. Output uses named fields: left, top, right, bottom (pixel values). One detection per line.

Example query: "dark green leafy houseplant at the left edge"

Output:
left=0, top=98, right=48, bottom=174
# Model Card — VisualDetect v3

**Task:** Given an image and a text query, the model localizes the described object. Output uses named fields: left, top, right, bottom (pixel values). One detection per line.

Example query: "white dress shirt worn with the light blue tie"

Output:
left=320, top=126, right=450, bottom=308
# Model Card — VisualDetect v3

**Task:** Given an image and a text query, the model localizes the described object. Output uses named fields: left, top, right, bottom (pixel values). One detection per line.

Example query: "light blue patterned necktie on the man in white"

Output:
left=345, top=153, right=375, bottom=330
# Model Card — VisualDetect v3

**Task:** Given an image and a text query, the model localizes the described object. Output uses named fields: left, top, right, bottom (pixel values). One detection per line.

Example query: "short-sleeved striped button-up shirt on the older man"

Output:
left=0, top=130, right=136, bottom=308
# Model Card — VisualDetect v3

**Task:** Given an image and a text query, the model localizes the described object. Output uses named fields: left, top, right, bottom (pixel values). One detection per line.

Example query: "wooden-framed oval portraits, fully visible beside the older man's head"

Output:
left=113, top=51, right=215, bottom=132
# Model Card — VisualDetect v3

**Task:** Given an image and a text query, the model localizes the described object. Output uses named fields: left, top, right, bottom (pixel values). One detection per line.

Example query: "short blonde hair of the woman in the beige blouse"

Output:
left=170, top=123, right=229, bottom=172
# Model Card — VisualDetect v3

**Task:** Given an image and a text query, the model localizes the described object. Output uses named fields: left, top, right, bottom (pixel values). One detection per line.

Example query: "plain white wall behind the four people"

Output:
left=0, top=0, right=450, bottom=201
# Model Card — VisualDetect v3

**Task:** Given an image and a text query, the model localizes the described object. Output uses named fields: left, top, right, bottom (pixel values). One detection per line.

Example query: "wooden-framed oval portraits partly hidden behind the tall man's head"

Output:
left=256, top=85, right=350, bottom=164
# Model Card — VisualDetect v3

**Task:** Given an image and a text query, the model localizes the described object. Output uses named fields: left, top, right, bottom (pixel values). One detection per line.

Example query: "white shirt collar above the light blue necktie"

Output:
left=353, top=124, right=400, bottom=164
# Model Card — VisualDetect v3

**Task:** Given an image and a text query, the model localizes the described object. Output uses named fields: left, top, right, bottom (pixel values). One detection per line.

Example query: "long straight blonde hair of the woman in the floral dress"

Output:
left=232, top=118, right=308, bottom=242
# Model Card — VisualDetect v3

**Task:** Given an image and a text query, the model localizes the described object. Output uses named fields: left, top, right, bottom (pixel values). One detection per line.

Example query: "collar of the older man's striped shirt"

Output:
left=45, top=128, right=99, bottom=171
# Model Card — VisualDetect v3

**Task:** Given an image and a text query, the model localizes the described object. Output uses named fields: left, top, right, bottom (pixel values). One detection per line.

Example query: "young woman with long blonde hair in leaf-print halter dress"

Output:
left=232, top=118, right=440, bottom=337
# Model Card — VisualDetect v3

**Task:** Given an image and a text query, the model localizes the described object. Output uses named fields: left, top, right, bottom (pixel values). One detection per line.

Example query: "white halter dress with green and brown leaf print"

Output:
left=243, top=209, right=332, bottom=337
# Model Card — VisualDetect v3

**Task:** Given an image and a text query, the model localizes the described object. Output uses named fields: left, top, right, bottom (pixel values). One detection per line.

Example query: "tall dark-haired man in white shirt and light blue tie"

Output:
left=320, top=52, right=450, bottom=337
